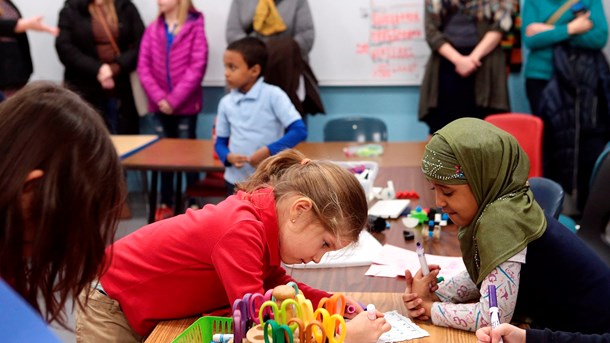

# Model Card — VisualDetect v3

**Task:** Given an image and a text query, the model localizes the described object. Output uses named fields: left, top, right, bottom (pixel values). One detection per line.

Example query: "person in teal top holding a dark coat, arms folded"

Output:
left=522, top=0, right=610, bottom=213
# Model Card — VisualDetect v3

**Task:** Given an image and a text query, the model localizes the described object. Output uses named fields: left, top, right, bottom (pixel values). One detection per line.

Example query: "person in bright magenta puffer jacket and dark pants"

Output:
left=137, top=0, right=208, bottom=220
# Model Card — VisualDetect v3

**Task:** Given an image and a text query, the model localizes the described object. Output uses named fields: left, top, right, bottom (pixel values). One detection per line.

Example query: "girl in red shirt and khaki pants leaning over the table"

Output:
left=76, top=150, right=390, bottom=343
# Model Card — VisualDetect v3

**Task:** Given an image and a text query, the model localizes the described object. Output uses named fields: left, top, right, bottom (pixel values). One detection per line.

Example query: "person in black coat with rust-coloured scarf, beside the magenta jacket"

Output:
left=55, top=0, right=144, bottom=134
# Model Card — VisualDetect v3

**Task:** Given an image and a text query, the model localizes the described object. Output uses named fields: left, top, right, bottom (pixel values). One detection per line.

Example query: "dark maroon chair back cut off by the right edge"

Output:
left=577, top=145, right=610, bottom=265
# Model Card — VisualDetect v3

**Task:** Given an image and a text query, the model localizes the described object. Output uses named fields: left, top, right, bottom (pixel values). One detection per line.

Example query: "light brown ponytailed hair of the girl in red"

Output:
left=236, top=149, right=368, bottom=242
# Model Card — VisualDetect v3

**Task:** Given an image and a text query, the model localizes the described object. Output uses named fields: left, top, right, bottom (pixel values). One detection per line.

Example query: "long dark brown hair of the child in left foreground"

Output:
left=0, top=82, right=125, bottom=327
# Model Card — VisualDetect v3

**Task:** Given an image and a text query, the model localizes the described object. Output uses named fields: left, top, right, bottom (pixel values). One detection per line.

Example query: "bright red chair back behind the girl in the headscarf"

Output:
left=485, top=113, right=544, bottom=177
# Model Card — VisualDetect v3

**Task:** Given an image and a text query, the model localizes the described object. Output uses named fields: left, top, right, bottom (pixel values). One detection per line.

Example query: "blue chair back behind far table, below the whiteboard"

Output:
left=324, top=117, right=388, bottom=143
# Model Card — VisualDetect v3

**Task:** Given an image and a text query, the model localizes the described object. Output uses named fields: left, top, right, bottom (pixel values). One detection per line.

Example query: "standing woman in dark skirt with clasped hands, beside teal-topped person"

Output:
left=419, top=0, right=516, bottom=134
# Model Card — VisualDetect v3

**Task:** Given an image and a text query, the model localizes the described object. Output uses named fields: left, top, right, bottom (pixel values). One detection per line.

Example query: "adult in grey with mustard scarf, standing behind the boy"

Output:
left=226, top=0, right=324, bottom=119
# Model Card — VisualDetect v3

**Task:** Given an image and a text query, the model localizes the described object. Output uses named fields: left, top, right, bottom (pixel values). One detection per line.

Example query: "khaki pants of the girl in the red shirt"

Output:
left=76, top=287, right=144, bottom=343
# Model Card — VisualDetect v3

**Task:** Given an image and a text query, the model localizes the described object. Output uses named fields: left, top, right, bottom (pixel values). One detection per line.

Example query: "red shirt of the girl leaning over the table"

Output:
left=100, top=189, right=329, bottom=336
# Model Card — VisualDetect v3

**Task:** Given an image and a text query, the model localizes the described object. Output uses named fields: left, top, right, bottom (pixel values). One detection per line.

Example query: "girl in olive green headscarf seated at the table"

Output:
left=403, top=118, right=610, bottom=333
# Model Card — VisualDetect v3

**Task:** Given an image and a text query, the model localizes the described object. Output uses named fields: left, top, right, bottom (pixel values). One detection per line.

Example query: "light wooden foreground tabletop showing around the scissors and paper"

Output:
left=146, top=292, right=477, bottom=343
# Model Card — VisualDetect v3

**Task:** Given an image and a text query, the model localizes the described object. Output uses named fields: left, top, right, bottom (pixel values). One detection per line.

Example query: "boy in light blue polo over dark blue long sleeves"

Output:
left=214, top=37, right=307, bottom=195
